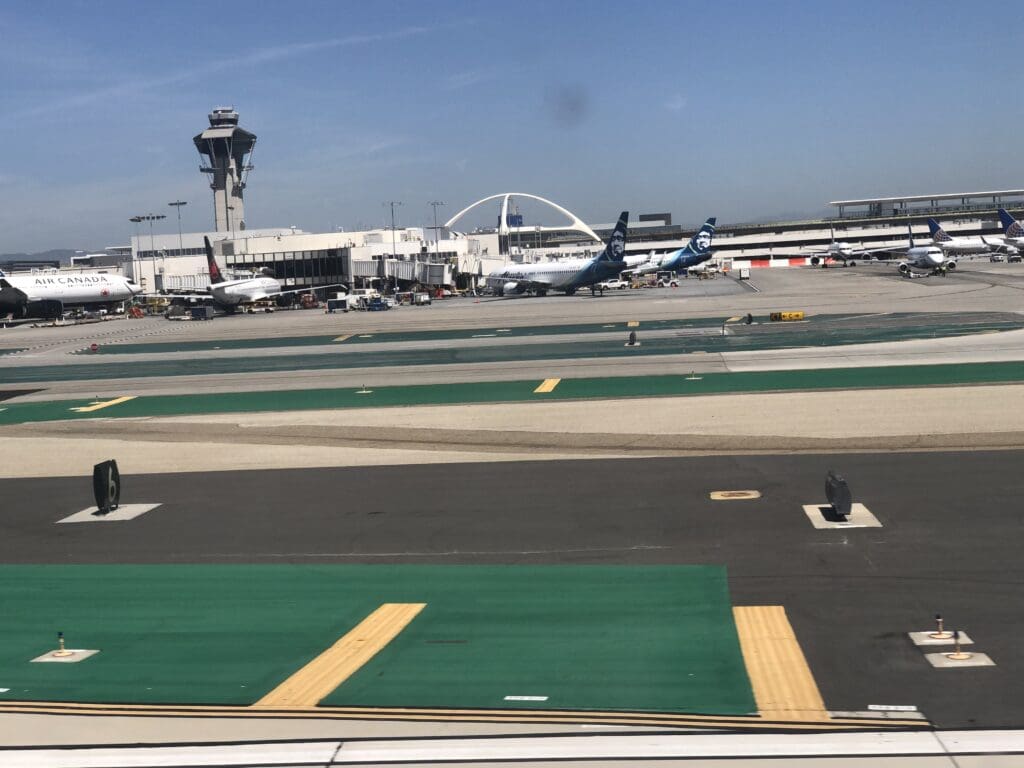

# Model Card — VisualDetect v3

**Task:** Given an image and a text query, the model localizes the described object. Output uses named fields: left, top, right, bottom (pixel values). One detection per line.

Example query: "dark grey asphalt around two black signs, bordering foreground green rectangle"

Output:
left=0, top=452, right=1024, bottom=727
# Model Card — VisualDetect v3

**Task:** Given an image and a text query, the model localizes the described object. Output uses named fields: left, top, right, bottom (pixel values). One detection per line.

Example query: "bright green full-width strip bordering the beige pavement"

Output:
left=0, top=362, right=1024, bottom=425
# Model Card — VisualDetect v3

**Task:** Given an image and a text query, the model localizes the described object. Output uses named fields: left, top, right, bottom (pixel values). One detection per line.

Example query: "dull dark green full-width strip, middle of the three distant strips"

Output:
left=0, top=318, right=1022, bottom=385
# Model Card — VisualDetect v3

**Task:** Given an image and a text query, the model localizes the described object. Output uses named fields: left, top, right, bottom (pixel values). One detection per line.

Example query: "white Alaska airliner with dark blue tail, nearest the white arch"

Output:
left=485, top=211, right=630, bottom=296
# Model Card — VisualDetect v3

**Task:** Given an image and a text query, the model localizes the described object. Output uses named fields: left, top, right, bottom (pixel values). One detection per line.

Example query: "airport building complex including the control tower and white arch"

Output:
left=18, top=106, right=1024, bottom=293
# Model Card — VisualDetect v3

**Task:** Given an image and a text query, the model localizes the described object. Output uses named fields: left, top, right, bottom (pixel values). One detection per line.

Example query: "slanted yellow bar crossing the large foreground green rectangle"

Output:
left=253, top=603, right=426, bottom=709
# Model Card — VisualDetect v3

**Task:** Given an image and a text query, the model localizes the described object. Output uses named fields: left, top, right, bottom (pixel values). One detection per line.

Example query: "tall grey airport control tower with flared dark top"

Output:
left=193, top=106, right=256, bottom=237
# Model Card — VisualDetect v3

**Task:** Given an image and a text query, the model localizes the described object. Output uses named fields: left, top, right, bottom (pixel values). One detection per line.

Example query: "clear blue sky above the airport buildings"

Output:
left=0, top=0, right=1024, bottom=253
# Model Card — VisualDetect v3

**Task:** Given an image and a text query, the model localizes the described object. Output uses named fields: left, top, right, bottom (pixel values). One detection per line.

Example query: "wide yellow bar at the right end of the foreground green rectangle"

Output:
left=732, top=605, right=828, bottom=722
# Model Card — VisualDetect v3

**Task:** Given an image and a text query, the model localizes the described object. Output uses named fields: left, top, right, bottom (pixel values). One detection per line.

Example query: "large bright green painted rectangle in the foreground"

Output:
left=0, top=565, right=756, bottom=715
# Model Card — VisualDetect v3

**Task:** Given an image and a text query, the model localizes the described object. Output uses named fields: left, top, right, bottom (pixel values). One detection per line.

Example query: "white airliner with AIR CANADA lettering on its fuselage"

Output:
left=0, top=271, right=142, bottom=318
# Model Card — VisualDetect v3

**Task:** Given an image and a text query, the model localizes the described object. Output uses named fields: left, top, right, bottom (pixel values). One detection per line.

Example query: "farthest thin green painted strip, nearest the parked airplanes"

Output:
left=76, top=317, right=726, bottom=355
